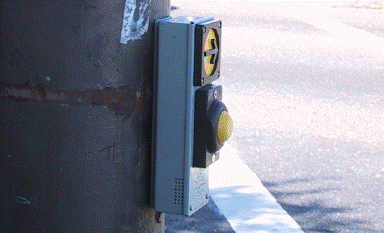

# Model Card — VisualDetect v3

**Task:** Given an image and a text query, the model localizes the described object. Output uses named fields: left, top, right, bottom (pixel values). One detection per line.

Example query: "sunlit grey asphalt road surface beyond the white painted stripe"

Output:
left=172, top=0, right=384, bottom=232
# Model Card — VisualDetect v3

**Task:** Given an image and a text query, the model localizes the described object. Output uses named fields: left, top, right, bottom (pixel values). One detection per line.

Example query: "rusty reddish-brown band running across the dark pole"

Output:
left=0, top=83, right=152, bottom=117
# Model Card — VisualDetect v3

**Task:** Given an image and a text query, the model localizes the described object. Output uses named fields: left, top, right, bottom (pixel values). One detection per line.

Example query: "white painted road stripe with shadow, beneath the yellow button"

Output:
left=209, top=145, right=303, bottom=233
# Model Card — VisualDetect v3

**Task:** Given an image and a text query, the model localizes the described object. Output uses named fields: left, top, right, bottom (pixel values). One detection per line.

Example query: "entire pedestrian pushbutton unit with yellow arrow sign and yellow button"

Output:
left=151, top=17, right=232, bottom=216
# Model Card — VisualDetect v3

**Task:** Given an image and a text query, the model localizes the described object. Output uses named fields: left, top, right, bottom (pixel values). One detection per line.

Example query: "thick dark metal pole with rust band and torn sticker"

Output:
left=0, top=0, right=170, bottom=233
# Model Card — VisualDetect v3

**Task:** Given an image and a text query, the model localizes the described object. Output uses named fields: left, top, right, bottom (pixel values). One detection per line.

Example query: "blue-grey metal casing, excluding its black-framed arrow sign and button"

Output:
left=151, top=17, right=214, bottom=216
